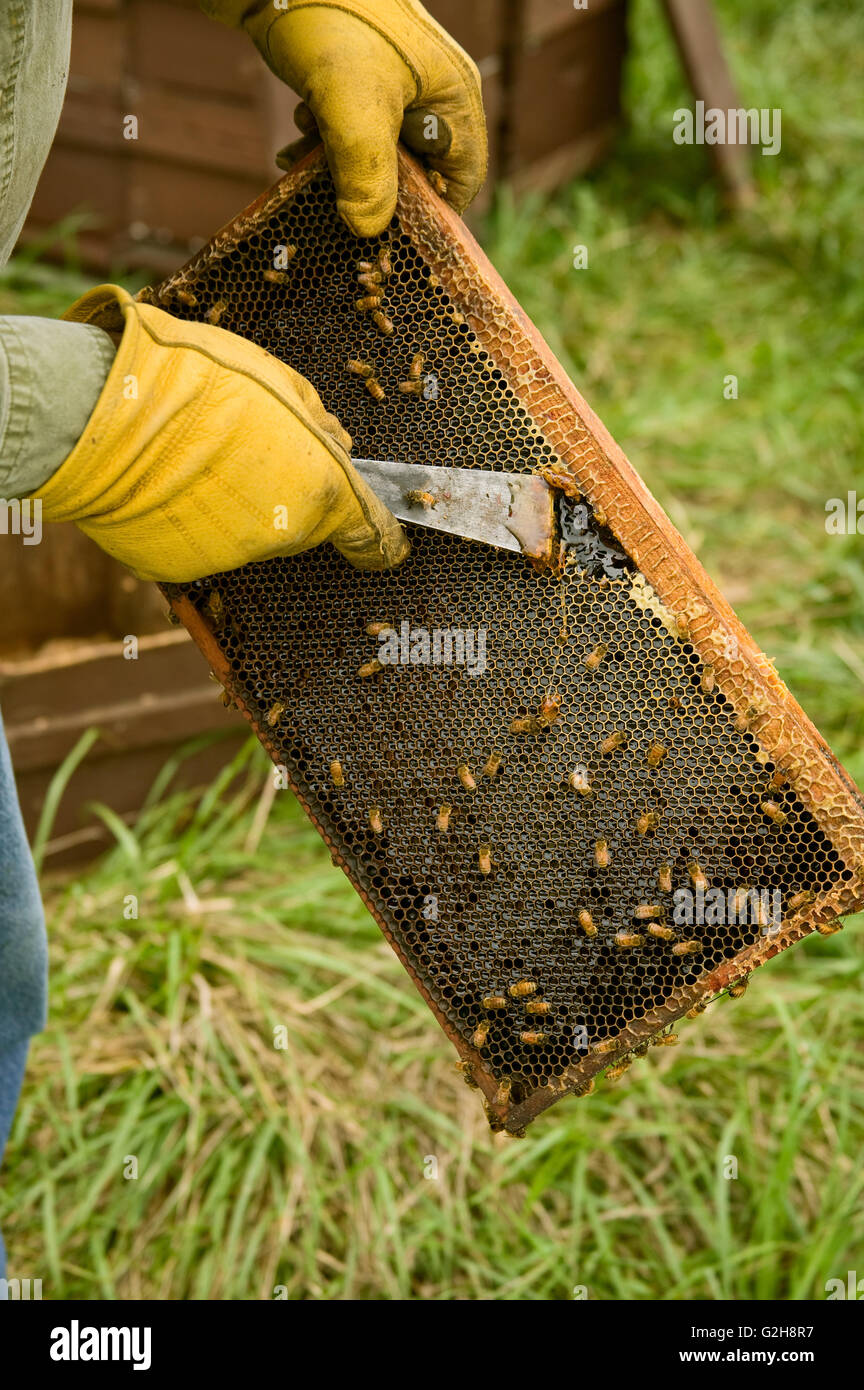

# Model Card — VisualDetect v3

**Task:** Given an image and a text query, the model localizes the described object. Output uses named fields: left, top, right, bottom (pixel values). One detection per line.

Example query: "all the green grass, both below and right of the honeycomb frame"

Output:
left=0, top=0, right=864, bottom=1300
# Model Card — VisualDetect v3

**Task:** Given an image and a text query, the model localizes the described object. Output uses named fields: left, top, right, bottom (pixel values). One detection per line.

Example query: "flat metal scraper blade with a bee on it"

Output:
left=353, top=459, right=556, bottom=557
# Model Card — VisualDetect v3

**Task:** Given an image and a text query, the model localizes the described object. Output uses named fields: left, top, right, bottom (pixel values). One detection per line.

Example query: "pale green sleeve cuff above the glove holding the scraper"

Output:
left=0, top=316, right=115, bottom=502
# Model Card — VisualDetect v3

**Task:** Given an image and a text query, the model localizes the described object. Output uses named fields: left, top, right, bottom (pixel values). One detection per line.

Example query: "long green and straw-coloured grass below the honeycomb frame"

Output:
left=3, top=745, right=864, bottom=1300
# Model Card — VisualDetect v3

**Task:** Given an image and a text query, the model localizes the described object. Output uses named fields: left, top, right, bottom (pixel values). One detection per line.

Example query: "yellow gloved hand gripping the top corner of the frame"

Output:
left=199, top=0, right=486, bottom=236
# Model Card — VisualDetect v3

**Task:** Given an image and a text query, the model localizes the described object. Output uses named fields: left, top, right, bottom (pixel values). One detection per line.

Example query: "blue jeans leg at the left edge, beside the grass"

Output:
left=0, top=706, right=47, bottom=1277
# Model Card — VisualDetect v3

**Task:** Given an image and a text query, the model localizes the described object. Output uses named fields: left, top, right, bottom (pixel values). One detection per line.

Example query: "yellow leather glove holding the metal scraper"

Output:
left=35, top=285, right=408, bottom=582
